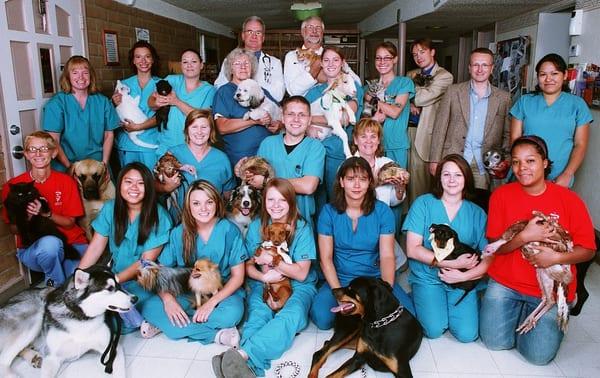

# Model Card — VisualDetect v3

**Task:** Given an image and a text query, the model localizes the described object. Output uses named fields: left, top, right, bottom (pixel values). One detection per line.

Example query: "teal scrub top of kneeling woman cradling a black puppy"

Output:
left=402, top=193, right=488, bottom=283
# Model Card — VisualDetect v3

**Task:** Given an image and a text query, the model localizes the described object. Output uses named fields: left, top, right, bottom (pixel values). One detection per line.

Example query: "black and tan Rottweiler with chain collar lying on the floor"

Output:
left=308, top=277, right=423, bottom=378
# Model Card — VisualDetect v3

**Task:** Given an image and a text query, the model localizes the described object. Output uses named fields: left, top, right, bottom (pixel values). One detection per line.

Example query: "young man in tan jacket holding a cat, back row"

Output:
left=406, top=38, right=453, bottom=205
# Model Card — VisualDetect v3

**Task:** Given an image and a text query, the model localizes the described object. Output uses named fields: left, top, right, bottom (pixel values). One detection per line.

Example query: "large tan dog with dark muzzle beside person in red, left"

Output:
left=67, top=159, right=115, bottom=240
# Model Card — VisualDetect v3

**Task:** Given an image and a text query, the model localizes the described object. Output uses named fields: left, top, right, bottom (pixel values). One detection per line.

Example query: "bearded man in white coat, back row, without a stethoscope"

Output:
left=283, top=16, right=360, bottom=96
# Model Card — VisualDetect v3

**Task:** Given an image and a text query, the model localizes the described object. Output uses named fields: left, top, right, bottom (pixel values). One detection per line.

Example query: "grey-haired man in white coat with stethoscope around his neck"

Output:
left=215, top=16, right=285, bottom=101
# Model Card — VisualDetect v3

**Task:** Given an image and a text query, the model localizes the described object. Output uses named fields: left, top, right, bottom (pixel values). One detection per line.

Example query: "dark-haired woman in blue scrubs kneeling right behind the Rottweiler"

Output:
left=310, top=157, right=414, bottom=329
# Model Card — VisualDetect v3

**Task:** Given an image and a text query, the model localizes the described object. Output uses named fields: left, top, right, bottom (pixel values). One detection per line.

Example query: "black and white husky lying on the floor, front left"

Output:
left=0, top=265, right=135, bottom=378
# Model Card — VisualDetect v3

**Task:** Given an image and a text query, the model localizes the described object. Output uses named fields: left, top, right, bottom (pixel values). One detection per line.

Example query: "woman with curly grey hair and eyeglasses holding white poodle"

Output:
left=213, top=48, right=278, bottom=167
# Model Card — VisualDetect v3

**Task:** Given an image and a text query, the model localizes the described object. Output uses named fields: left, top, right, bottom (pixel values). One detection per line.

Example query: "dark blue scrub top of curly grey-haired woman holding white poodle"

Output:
left=213, top=82, right=276, bottom=166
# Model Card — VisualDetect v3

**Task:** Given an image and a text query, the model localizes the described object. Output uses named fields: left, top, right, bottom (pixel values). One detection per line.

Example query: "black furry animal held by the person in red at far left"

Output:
left=4, top=181, right=80, bottom=260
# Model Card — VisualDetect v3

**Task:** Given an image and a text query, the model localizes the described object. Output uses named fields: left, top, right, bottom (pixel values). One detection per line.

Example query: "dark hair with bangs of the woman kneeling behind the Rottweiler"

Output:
left=331, top=157, right=377, bottom=214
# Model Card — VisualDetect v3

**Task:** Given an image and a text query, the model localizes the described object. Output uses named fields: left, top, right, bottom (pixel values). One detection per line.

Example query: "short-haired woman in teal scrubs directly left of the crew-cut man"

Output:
left=157, top=109, right=235, bottom=223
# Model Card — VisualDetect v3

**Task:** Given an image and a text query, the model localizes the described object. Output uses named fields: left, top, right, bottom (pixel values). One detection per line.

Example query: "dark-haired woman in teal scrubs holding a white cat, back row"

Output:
left=112, top=40, right=160, bottom=169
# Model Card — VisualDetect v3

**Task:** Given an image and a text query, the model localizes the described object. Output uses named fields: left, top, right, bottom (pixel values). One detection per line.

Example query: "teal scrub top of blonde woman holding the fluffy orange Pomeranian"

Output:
left=159, top=218, right=248, bottom=283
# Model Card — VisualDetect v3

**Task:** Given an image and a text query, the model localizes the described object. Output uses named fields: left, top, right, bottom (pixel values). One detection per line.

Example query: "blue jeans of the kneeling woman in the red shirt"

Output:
left=479, top=279, right=563, bottom=365
